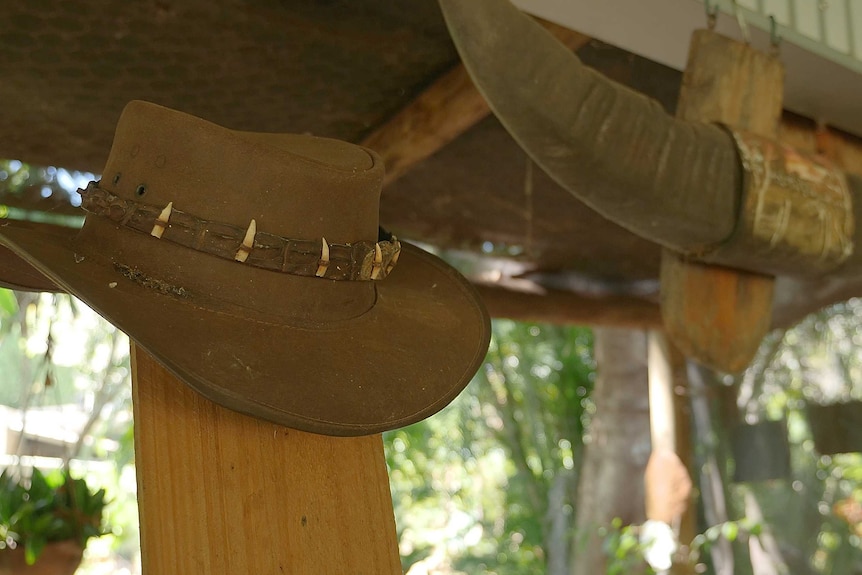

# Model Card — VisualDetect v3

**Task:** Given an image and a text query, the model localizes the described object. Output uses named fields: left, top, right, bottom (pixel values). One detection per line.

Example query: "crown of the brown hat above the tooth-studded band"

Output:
left=101, top=102, right=383, bottom=243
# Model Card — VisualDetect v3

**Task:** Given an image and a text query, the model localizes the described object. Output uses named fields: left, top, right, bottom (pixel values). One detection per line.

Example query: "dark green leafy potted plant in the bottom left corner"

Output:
left=0, top=469, right=107, bottom=565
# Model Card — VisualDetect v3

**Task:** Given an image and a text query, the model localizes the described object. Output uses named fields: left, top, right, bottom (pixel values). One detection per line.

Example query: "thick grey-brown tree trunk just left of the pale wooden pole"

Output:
left=571, top=328, right=650, bottom=575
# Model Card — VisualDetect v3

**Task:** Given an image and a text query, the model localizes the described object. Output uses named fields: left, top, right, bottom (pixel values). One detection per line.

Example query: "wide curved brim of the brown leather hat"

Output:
left=0, top=222, right=490, bottom=436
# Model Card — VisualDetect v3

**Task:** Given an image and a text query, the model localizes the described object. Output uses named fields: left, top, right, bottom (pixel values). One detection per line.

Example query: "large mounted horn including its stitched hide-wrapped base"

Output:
left=440, top=0, right=862, bottom=276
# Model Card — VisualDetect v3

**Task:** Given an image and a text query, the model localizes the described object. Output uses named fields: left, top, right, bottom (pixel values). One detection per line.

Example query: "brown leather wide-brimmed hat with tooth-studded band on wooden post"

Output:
left=0, top=102, right=490, bottom=435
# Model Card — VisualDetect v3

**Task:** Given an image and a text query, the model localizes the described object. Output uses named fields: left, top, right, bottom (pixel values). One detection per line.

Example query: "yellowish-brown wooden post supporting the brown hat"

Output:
left=132, top=346, right=401, bottom=575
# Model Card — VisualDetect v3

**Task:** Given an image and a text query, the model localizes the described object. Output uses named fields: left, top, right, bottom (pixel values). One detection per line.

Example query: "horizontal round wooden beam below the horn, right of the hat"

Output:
left=473, top=281, right=661, bottom=329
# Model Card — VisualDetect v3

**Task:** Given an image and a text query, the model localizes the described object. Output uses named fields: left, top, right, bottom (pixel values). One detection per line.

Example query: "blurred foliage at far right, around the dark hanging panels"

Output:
left=731, top=299, right=862, bottom=573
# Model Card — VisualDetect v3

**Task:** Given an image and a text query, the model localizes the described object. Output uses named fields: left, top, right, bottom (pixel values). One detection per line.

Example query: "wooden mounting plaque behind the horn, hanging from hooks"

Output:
left=661, top=30, right=784, bottom=372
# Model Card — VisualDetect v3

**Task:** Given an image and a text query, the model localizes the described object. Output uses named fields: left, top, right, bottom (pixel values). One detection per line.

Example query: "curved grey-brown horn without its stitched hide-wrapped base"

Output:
left=440, top=0, right=742, bottom=253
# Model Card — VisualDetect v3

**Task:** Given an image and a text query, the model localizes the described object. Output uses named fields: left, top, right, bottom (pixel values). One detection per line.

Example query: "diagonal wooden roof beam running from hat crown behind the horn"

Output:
left=362, top=20, right=590, bottom=187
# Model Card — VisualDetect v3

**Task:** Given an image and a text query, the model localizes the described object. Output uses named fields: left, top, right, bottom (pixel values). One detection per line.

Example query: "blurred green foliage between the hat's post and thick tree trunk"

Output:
left=384, top=321, right=594, bottom=575
